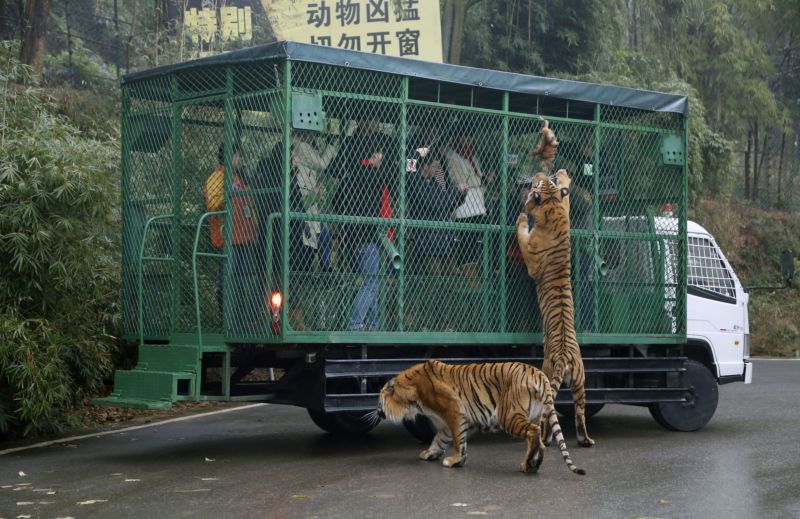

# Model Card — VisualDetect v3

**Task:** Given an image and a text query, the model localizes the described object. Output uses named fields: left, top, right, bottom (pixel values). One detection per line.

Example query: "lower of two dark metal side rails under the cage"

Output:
left=325, top=387, right=689, bottom=412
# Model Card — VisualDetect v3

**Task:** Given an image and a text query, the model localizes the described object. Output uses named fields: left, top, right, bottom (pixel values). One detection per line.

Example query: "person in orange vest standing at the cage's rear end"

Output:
left=204, top=141, right=260, bottom=327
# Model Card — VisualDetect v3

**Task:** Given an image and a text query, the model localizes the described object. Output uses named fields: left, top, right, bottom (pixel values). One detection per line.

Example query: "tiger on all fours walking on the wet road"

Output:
left=376, top=360, right=586, bottom=475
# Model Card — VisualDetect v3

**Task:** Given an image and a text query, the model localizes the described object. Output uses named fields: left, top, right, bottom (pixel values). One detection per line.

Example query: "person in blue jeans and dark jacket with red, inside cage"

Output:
left=335, top=133, right=393, bottom=330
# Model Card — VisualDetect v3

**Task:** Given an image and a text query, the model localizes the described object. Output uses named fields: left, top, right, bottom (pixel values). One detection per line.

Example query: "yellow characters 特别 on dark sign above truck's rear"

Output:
left=183, top=1, right=253, bottom=56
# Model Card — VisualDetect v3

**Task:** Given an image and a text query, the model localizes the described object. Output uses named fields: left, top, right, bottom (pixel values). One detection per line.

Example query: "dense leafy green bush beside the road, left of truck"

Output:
left=0, top=43, right=119, bottom=435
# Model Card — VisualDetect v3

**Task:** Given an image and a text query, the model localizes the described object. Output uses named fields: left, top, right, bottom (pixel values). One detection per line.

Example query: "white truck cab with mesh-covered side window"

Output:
left=686, top=221, right=753, bottom=384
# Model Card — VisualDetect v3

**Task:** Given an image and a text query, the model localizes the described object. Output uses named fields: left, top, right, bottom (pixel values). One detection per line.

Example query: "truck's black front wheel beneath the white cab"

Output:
left=649, top=360, right=719, bottom=432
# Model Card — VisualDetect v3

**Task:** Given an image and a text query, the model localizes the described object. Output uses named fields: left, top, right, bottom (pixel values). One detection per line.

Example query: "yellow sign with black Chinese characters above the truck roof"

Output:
left=261, top=0, right=442, bottom=63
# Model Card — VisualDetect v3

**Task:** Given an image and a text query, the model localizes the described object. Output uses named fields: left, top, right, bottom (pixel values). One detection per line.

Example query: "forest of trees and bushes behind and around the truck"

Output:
left=0, top=0, right=800, bottom=439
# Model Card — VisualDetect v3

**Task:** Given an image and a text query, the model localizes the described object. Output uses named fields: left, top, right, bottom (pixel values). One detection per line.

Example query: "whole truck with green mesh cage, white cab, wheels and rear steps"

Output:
left=96, top=42, right=752, bottom=438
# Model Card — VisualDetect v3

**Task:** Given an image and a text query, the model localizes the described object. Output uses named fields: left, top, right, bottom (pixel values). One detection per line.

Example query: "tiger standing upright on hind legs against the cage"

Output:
left=517, top=121, right=594, bottom=447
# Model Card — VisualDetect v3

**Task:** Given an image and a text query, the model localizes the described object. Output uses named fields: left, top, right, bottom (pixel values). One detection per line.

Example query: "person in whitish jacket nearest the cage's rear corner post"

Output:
left=292, top=130, right=337, bottom=271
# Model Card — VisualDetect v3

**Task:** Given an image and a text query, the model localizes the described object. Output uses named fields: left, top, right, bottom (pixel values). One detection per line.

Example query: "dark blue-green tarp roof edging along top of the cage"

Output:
left=122, top=41, right=689, bottom=115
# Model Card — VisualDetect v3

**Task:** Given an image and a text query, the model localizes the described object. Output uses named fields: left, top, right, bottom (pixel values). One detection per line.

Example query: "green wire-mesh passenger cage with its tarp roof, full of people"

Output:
left=122, top=42, right=687, bottom=354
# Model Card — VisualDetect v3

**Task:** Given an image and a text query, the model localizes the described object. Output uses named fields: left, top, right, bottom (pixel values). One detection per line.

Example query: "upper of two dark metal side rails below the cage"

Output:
left=325, top=357, right=686, bottom=379
